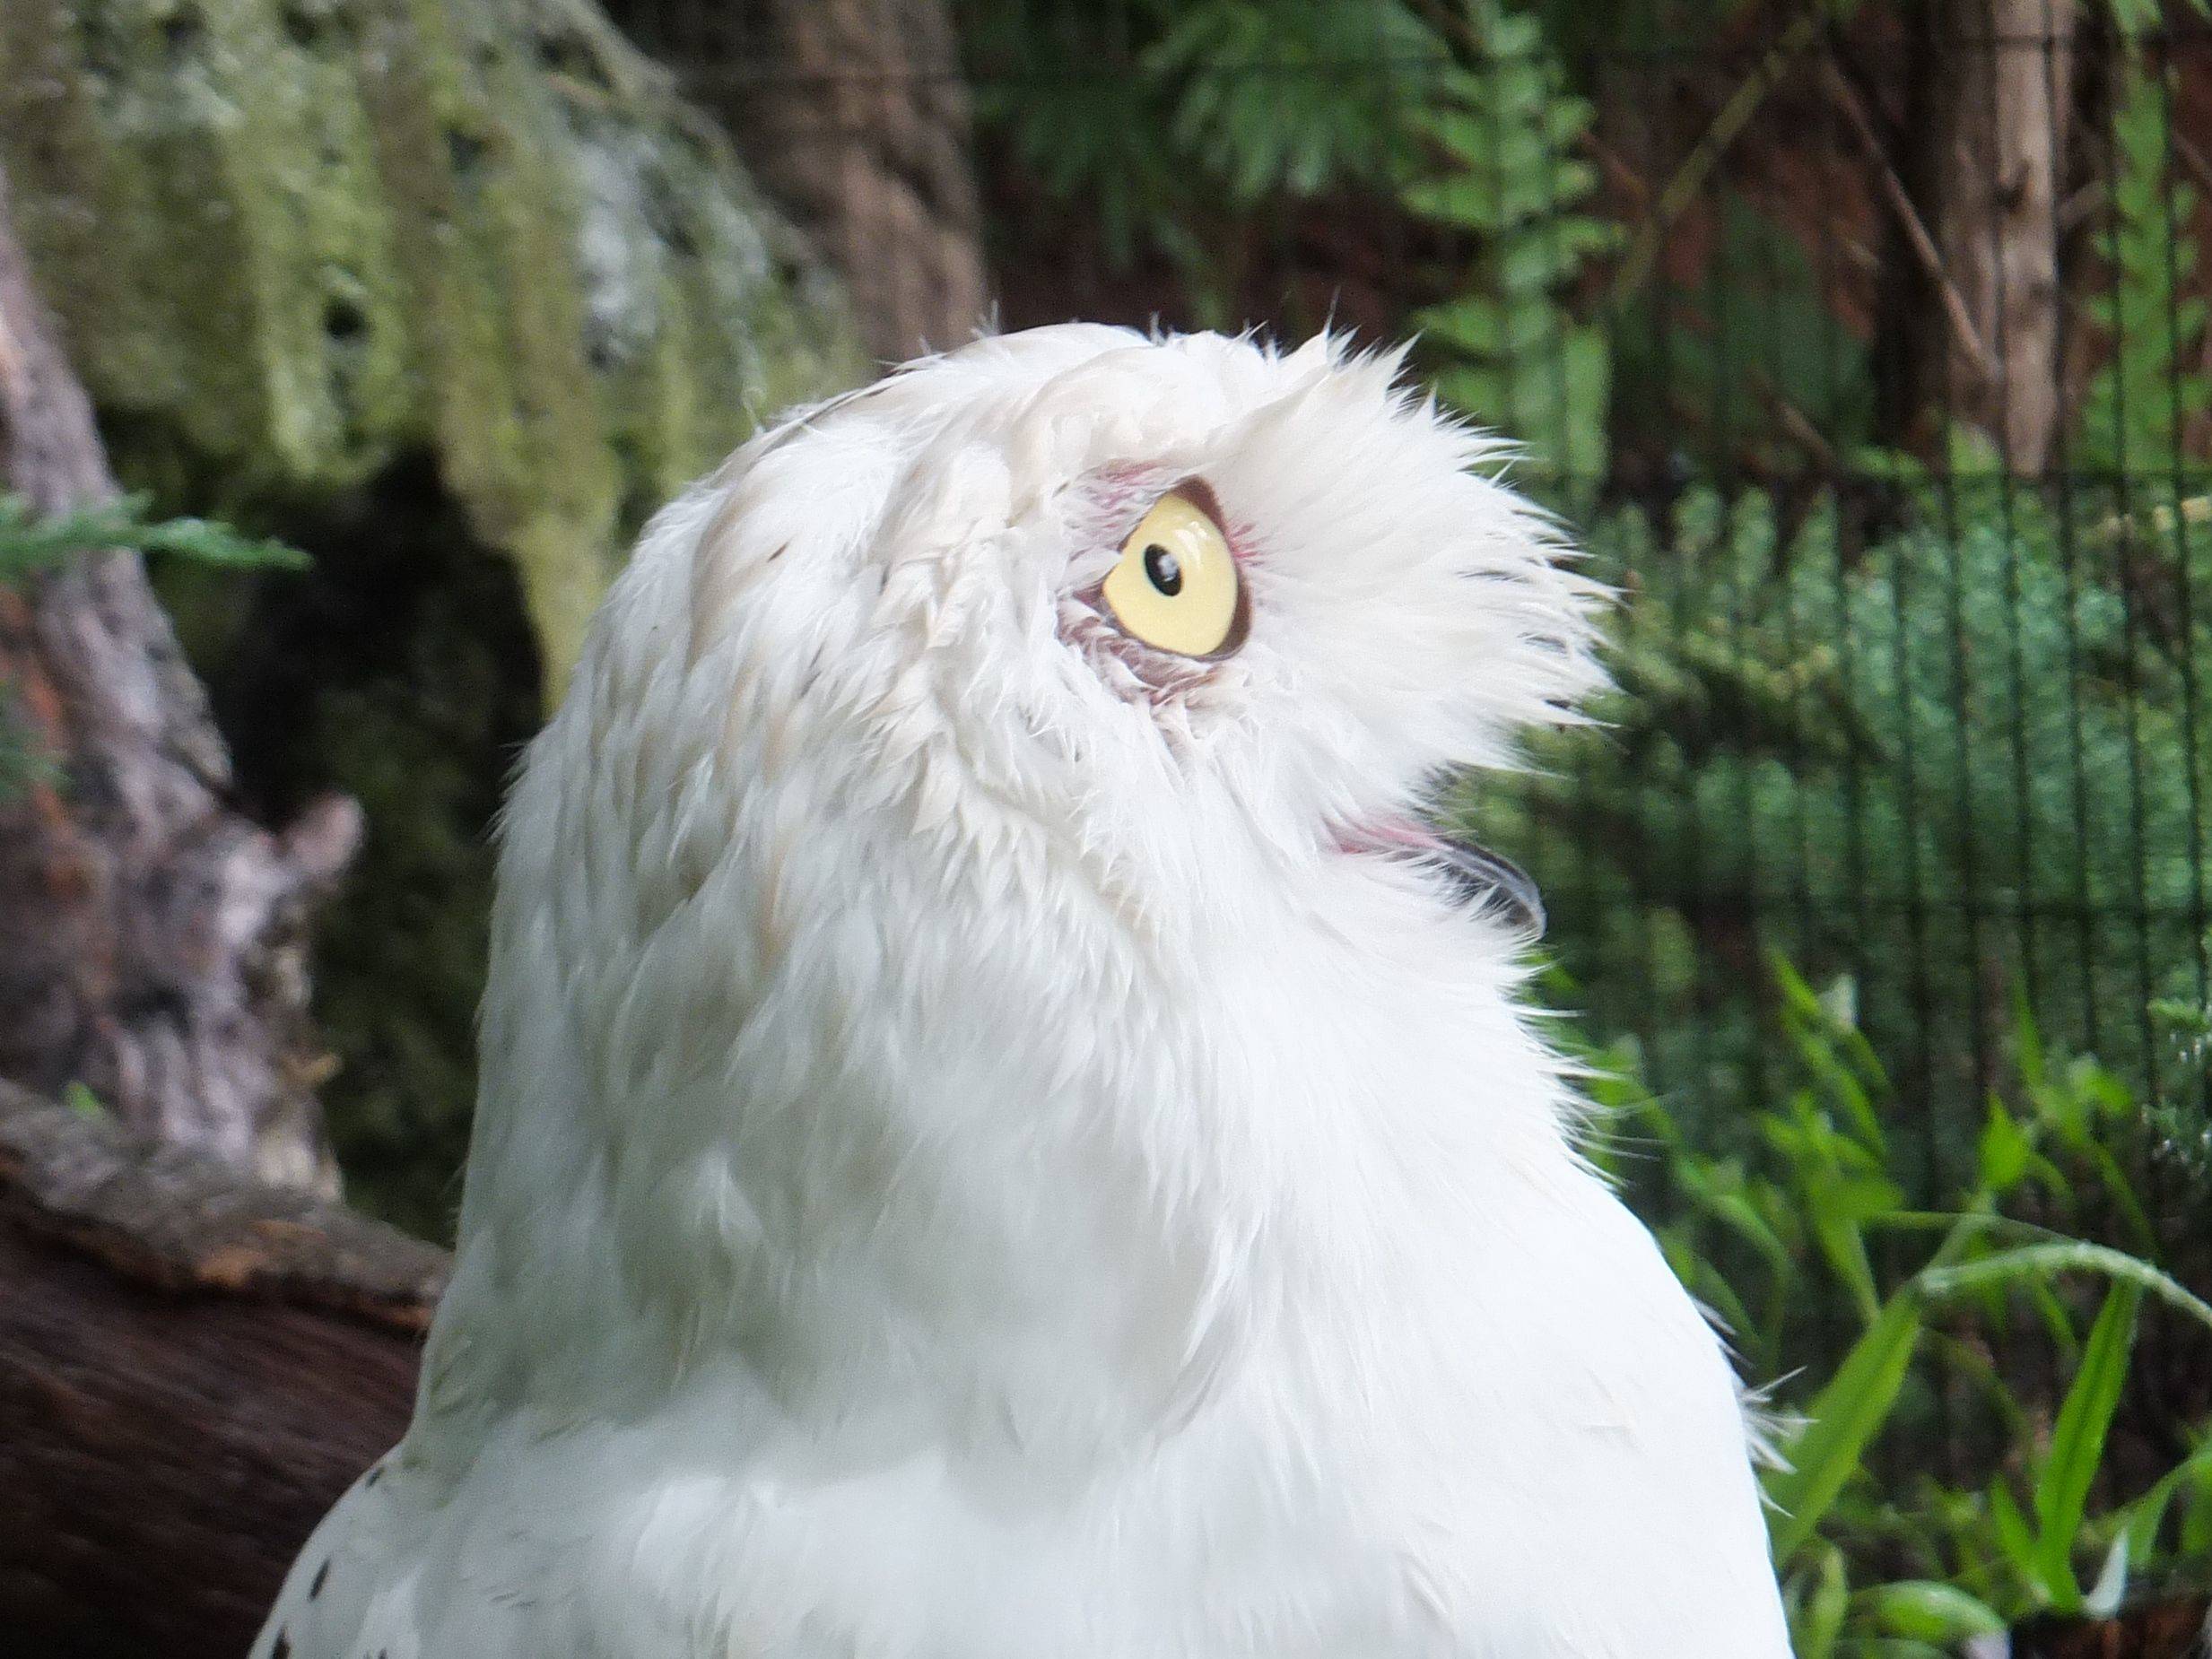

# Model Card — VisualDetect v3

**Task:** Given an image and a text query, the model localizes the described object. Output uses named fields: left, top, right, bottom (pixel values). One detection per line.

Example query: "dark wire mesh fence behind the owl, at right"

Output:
left=615, top=0, right=2212, bottom=1203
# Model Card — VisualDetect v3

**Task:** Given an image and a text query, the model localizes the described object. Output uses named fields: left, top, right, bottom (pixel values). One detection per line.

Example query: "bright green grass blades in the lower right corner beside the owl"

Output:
left=1595, top=962, right=2212, bottom=1657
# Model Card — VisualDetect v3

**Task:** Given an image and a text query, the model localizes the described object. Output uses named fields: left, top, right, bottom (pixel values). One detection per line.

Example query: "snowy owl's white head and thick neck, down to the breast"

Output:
left=448, top=326, right=1599, bottom=1442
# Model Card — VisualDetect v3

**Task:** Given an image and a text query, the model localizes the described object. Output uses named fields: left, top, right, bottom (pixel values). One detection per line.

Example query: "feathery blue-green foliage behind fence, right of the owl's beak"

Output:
left=1471, top=454, right=2212, bottom=1179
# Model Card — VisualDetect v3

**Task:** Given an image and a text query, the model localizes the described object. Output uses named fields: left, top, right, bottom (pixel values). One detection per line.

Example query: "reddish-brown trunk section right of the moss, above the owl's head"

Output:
left=723, top=0, right=987, bottom=360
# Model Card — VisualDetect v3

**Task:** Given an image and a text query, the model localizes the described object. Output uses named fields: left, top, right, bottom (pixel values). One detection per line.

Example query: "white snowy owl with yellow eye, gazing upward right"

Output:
left=255, top=326, right=1788, bottom=1659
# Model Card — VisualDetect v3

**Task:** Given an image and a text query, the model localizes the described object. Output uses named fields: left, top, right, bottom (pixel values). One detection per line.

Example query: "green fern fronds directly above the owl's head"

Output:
left=960, top=0, right=1619, bottom=480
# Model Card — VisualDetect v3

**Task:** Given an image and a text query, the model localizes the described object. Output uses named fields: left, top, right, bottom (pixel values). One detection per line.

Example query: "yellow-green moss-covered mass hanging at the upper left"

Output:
left=0, top=0, right=865, bottom=683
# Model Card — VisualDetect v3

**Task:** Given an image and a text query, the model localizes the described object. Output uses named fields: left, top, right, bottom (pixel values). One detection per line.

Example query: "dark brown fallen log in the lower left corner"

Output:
left=0, top=1086, right=445, bottom=1659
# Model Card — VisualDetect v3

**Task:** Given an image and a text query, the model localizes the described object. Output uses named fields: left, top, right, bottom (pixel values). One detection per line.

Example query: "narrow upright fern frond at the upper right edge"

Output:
left=2070, top=65, right=2212, bottom=473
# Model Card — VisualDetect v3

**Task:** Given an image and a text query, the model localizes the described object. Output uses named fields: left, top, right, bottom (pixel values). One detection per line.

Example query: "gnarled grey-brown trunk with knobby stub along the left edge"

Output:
left=0, top=159, right=361, bottom=1190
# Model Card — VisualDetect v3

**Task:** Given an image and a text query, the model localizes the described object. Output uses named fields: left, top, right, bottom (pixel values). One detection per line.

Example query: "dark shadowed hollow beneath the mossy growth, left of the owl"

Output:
left=188, top=458, right=542, bottom=1238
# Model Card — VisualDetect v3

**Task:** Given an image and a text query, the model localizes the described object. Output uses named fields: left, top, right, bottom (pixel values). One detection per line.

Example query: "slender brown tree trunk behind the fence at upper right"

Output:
left=1927, top=0, right=2075, bottom=473
